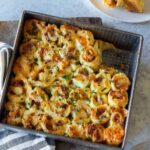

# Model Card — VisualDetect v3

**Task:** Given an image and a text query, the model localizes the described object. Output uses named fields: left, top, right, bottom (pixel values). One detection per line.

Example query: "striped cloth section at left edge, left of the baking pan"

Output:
left=0, top=42, right=13, bottom=95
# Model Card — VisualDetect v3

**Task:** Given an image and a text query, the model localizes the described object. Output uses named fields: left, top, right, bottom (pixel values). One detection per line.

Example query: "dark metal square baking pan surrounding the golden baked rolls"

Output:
left=0, top=11, right=143, bottom=150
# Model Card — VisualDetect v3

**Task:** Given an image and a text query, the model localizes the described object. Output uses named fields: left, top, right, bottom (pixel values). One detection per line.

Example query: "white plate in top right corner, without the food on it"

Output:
left=90, top=0, right=150, bottom=23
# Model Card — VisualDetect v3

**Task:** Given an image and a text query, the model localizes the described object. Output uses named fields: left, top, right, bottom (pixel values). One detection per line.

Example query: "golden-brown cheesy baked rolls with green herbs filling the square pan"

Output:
left=4, top=19, right=130, bottom=145
